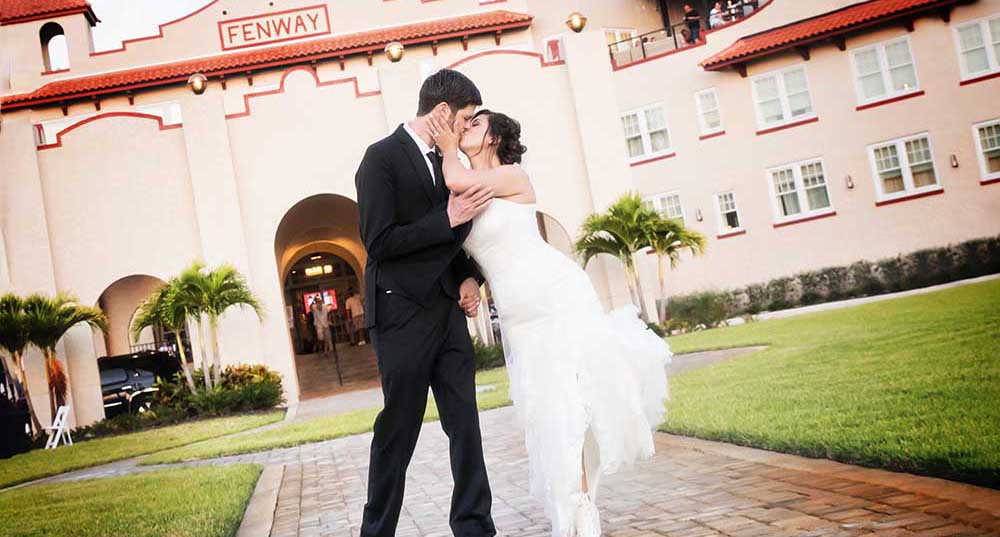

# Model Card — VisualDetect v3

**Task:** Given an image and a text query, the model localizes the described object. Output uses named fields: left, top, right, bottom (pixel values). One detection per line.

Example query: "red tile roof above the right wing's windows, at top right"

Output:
left=700, top=0, right=964, bottom=71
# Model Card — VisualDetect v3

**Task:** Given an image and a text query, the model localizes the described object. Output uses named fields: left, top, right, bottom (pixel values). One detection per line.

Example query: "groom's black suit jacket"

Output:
left=354, top=125, right=483, bottom=328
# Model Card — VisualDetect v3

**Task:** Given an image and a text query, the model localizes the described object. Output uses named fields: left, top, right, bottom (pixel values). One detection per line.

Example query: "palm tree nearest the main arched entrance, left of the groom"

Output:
left=178, top=261, right=263, bottom=389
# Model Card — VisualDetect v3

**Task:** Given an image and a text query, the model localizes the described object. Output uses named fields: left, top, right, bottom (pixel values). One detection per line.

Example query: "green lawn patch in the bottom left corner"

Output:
left=0, top=465, right=261, bottom=537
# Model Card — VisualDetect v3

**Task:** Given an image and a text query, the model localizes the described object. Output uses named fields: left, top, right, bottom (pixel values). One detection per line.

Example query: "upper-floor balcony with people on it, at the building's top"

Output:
left=608, top=0, right=771, bottom=69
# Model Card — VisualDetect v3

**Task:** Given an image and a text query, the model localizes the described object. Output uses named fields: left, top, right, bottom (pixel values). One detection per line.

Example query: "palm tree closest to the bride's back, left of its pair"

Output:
left=574, top=193, right=663, bottom=320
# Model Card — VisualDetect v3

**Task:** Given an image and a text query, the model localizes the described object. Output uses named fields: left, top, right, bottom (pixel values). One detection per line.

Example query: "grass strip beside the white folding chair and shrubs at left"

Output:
left=0, top=410, right=285, bottom=488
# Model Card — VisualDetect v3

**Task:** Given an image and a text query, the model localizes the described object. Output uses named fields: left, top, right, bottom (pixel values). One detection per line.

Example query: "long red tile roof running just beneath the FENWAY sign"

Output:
left=0, top=11, right=532, bottom=110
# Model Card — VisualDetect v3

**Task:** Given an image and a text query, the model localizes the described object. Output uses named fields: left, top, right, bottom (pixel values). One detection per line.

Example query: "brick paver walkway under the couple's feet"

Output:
left=260, top=408, right=1000, bottom=537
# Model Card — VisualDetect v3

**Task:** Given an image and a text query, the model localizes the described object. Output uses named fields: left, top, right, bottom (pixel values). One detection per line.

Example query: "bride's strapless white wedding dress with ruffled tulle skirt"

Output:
left=465, top=199, right=670, bottom=537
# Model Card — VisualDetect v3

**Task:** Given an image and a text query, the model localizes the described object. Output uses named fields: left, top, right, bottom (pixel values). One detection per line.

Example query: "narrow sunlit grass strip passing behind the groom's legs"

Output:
left=141, top=368, right=510, bottom=465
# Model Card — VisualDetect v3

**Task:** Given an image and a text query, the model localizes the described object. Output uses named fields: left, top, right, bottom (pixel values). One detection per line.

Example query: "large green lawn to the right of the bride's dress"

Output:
left=662, top=281, right=1000, bottom=487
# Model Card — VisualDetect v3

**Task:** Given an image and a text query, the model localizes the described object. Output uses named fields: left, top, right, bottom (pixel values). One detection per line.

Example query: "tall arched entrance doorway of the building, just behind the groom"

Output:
left=274, top=194, right=378, bottom=399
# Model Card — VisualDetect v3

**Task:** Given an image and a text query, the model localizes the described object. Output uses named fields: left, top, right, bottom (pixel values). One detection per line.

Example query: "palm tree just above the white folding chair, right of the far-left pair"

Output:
left=24, top=292, right=108, bottom=416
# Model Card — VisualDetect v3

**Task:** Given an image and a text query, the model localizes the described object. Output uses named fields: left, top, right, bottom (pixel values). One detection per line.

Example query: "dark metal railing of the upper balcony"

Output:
left=608, top=0, right=770, bottom=67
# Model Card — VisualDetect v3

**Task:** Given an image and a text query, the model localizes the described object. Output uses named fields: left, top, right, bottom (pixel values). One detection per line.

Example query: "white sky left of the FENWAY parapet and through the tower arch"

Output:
left=52, top=0, right=211, bottom=66
